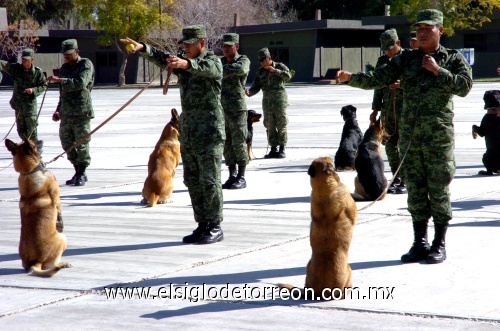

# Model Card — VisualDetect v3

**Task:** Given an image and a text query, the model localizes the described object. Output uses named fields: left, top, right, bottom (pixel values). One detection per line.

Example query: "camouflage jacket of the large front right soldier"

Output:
left=349, top=46, right=472, bottom=148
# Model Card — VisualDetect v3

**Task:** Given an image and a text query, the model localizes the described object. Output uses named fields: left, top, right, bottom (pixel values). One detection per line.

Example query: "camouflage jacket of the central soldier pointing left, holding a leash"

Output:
left=139, top=44, right=226, bottom=146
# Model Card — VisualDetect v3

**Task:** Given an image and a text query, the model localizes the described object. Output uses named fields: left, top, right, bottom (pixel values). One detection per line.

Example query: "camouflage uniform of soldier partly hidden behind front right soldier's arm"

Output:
left=372, top=48, right=403, bottom=179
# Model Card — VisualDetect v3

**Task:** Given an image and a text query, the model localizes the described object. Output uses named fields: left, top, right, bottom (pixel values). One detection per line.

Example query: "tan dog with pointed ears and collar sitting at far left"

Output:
left=5, top=139, right=71, bottom=277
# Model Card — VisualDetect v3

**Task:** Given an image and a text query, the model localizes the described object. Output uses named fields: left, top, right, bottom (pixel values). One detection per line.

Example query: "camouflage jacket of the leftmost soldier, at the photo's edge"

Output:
left=0, top=61, right=47, bottom=108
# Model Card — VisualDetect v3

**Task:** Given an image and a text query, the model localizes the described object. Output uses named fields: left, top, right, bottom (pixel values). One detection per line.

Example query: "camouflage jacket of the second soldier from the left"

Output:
left=57, top=56, right=95, bottom=119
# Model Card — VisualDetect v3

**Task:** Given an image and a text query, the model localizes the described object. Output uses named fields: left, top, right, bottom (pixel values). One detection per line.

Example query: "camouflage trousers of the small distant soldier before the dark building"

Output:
left=262, top=97, right=288, bottom=146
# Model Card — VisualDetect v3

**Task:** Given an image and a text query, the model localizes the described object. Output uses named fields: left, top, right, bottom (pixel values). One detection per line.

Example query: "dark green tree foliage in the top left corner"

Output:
left=0, top=0, right=74, bottom=25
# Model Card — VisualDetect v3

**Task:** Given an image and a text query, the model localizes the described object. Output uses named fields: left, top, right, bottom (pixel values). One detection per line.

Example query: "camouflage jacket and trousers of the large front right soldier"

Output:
left=349, top=46, right=472, bottom=224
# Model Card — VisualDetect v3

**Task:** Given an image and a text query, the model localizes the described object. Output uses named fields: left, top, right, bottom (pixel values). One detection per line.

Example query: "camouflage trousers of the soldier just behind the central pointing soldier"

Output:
left=224, top=110, right=248, bottom=166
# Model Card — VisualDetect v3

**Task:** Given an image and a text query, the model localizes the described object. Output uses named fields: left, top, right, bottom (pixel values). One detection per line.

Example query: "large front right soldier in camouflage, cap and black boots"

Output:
left=337, top=9, right=472, bottom=263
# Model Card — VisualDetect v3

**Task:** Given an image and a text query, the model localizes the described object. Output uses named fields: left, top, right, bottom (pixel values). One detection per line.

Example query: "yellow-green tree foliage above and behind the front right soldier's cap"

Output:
left=391, top=0, right=500, bottom=36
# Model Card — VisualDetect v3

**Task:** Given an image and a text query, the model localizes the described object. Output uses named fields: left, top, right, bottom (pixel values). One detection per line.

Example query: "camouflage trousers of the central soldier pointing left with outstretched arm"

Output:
left=181, top=141, right=224, bottom=224
